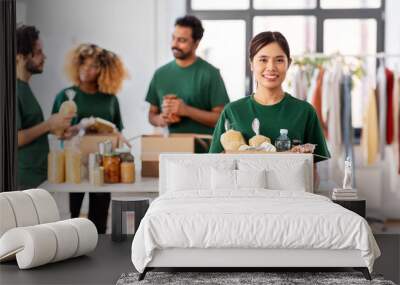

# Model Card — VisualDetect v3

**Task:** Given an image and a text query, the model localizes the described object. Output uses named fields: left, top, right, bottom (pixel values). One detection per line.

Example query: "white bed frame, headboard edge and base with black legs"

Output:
left=139, top=154, right=371, bottom=280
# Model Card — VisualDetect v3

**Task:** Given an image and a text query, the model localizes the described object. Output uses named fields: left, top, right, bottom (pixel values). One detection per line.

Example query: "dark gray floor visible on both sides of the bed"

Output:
left=0, top=232, right=400, bottom=285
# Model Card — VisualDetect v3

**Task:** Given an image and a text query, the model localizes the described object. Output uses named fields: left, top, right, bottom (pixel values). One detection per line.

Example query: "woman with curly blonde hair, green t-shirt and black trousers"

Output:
left=52, top=44, right=126, bottom=233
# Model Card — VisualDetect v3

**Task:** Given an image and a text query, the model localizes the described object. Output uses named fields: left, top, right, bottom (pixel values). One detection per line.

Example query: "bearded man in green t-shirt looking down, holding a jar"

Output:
left=146, top=16, right=229, bottom=134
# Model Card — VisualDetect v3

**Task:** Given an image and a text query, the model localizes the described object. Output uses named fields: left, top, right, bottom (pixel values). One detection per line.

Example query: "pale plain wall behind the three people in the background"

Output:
left=17, top=0, right=185, bottom=160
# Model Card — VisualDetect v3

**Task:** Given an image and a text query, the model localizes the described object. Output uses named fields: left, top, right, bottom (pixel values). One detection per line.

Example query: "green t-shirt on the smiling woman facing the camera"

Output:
left=210, top=93, right=330, bottom=162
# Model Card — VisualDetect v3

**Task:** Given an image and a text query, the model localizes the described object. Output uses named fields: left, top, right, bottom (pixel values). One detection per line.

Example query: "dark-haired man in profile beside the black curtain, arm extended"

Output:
left=16, top=26, right=71, bottom=190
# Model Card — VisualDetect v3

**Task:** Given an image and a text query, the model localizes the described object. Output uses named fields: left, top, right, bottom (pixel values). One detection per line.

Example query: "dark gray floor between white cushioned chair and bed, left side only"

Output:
left=0, top=235, right=134, bottom=285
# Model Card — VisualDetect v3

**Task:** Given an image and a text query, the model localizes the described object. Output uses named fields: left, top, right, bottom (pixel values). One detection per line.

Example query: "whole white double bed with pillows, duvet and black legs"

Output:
left=132, top=154, right=380, bottom=280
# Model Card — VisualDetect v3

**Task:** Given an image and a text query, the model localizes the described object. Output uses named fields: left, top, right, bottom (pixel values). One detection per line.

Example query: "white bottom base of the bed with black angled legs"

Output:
left=139, top=248, right=371, bottom=281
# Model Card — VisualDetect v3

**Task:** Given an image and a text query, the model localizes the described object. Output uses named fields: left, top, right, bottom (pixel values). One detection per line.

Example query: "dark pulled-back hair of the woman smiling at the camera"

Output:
left=249, top=31, right=290, bottom=61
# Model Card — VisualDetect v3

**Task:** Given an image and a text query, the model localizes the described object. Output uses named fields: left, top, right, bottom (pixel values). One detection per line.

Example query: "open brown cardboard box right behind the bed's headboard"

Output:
left=141, top=134, right=212, bottom=177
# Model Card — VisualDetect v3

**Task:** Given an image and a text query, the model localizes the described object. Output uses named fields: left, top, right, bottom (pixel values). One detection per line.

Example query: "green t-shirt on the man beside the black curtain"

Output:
left=17, top=80, right=49, bottom=189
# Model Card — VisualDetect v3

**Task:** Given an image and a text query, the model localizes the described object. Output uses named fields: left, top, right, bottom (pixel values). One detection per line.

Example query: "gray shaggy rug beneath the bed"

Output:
left=117, top=272, right=395, bottom=285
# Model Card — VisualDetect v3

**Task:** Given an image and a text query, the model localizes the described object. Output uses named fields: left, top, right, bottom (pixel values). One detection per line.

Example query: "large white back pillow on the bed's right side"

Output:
left=238, top=159, right=308, bottom=191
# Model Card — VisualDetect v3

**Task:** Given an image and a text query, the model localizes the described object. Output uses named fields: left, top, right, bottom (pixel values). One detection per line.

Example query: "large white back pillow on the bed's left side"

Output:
left=166, top=160, right=235, bottom=191
